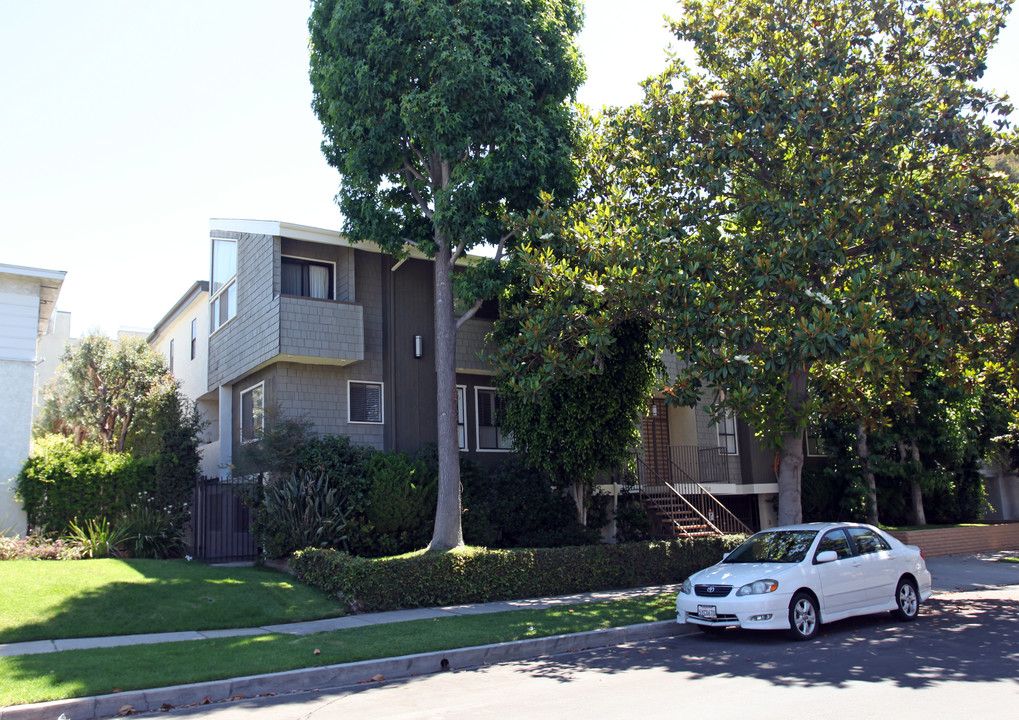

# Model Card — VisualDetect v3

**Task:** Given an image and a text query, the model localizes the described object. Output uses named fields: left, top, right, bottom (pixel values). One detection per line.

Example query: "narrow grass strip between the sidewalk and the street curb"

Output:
left=0, top=595, right=676, bottom=707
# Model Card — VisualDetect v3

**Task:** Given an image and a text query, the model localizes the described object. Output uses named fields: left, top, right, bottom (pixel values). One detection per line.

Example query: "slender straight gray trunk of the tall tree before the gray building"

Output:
left=428, top=242, right=464, bottom=551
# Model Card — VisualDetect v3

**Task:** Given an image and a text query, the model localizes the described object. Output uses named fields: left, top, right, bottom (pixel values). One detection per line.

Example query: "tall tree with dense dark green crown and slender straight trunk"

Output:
left=309, top=0, right=583, bottom=550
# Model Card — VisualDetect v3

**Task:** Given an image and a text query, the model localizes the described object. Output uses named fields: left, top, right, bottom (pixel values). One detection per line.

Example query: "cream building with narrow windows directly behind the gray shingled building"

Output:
left=147, top=280, right=220, bottom=478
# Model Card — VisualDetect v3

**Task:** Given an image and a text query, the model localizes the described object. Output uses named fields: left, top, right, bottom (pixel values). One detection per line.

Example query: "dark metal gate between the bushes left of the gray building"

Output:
left=187, top=478, right=258, bottom=563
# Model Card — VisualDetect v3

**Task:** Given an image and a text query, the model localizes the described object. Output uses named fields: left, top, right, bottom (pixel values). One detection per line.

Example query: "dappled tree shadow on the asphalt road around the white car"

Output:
left=520, top=596, right=1019, bottom=689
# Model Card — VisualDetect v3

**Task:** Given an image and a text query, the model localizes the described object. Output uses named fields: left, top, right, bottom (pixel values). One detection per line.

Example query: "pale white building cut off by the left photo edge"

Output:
left=0, top=265, right=66, bottom=535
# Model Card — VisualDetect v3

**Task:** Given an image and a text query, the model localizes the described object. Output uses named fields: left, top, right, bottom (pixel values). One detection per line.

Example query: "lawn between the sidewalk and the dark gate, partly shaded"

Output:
left=0, top=560, right=344, bottom=643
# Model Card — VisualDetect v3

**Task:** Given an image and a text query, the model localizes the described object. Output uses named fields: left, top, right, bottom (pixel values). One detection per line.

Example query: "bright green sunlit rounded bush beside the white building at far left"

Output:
left=15, top=435, right=146, bottom=534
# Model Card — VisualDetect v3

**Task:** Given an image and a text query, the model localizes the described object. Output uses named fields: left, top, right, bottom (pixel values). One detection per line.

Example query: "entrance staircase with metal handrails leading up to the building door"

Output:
left=635, top=455, right=753, bottom=538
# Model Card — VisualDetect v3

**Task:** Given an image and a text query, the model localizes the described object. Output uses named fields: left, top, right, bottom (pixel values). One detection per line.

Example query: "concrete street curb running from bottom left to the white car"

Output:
left=0, top=620, right=690, bottom=720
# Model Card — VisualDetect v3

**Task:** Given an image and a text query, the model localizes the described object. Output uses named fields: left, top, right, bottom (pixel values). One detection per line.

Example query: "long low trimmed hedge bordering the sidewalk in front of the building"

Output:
left=290, top=536, right=744, bottom=612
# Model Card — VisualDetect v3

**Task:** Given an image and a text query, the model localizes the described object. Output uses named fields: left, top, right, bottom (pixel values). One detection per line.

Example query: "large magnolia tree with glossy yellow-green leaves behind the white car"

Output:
left=497, top=0, right=1019, bottom=523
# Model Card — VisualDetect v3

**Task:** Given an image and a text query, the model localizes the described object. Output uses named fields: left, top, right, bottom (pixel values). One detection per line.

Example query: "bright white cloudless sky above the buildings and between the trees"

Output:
left=0, top=0, right=1019, bottom=336
